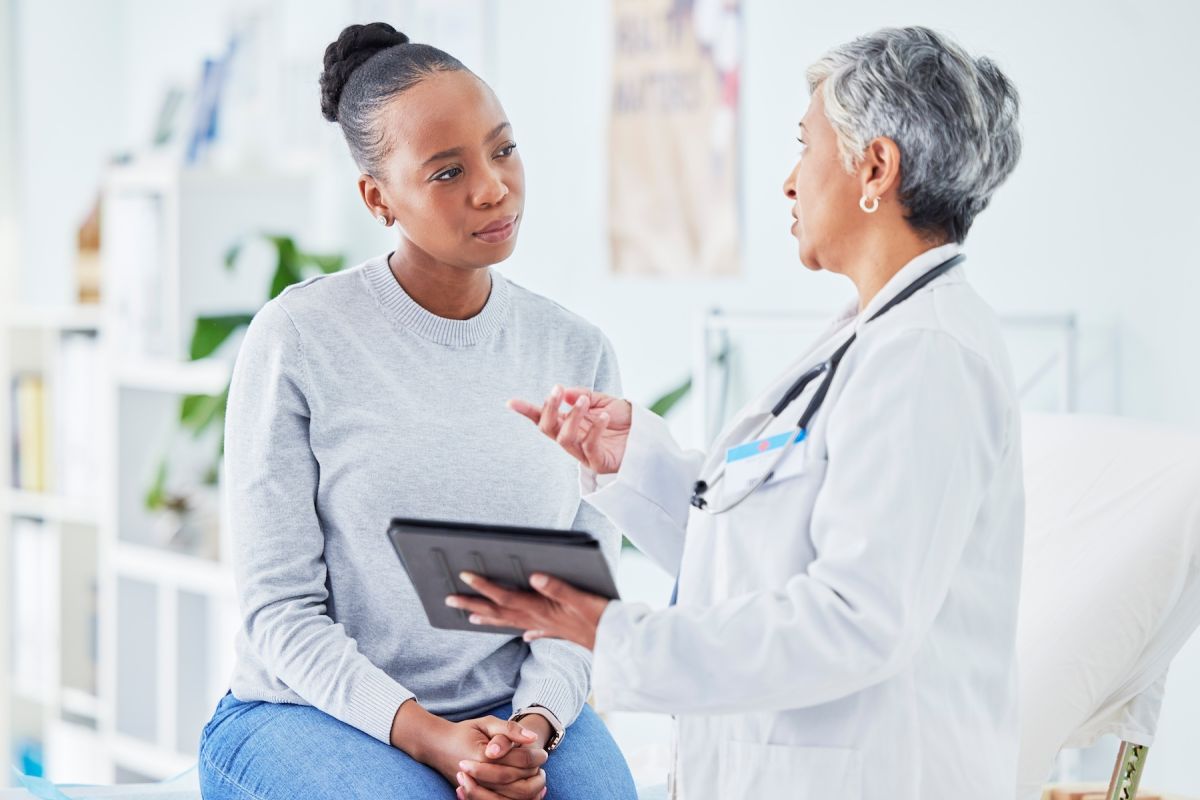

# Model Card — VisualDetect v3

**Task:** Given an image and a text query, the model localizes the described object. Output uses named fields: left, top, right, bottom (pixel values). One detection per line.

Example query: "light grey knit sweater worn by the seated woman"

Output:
left=226, top=257, right=619, bottom=741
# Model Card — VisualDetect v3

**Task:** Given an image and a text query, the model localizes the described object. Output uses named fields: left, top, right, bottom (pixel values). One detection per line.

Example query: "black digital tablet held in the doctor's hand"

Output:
left=388, top=518, right=619, bottom=633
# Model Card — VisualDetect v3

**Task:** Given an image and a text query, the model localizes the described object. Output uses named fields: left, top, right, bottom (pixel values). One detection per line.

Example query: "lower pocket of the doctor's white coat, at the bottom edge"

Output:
left=716, top=740, right=863, bottom=800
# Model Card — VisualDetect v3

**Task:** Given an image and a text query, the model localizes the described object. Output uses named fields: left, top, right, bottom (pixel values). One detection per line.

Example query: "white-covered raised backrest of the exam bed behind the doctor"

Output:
left=1018, top=415, right=1200, bottom=796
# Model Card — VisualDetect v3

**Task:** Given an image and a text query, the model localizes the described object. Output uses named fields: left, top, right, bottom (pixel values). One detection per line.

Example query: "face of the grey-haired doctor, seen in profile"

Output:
left=784, top=86, right=859, bottom=270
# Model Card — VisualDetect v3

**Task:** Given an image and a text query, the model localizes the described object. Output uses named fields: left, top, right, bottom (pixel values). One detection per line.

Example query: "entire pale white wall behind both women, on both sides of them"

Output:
left=9, top=0, right=1200, bottom=793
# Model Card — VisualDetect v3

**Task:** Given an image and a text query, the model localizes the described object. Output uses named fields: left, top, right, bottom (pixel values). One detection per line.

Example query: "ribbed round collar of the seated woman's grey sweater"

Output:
left=362, top=255, right=509, bottom=347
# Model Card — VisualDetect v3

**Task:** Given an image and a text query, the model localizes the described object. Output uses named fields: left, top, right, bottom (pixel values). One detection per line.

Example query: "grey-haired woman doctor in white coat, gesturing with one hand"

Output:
left=448, top=28, right=1024, bottom=800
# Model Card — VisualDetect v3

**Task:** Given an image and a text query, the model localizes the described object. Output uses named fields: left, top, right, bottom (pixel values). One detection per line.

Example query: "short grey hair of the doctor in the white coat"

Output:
left=808, top=28, right=1021, bottom=242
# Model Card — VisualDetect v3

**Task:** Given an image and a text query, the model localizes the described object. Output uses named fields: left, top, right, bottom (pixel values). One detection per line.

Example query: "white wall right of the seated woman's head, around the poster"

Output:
left=492, top=0, right=1200, bottom=427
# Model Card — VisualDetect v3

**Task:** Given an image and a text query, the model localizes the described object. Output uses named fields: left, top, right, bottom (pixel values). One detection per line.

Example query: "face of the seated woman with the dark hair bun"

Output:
left=374, top=72, right=524, bottom=269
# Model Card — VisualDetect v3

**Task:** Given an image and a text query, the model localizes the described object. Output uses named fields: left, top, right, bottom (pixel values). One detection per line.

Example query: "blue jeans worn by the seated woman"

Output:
left=199, top=694, right=637, bottom=800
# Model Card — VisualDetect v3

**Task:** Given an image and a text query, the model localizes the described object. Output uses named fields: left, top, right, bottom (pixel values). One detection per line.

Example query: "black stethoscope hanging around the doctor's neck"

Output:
left=691, top=253, right=966, bottom=515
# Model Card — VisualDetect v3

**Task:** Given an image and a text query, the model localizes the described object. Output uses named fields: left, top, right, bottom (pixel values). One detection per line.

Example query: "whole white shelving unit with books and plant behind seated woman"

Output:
left=0, top=159, right=311, bottom=786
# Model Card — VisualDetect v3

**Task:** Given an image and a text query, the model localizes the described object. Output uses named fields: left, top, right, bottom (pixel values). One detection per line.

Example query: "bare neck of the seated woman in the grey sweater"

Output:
left=388, top=241, right=492, bottom=319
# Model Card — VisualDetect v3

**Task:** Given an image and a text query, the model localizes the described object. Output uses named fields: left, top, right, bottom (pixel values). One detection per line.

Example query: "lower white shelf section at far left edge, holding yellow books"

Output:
left=0, top=305, right=109, bottom=781
